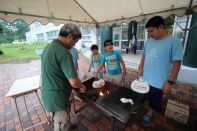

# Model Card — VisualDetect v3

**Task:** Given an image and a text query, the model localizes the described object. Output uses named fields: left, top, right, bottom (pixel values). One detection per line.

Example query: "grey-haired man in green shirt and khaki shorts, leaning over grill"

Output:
left=41, top=24, right=86, bottom=131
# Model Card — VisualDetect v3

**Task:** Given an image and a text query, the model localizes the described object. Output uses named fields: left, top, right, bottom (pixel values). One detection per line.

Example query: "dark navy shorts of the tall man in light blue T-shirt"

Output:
left=140, top=85, right=163, bottom=112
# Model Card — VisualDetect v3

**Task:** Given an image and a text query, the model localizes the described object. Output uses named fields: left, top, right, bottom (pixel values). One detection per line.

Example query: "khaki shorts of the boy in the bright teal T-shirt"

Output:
left=107, top=74, right=122, bottom=86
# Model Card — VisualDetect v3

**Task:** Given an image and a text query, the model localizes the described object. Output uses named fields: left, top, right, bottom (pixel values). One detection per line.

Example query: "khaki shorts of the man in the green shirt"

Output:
left=47, top=111, right=71, bottom=131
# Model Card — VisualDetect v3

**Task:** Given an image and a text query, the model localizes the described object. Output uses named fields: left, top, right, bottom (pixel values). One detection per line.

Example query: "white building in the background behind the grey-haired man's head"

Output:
left=25, top=22, right=96, bottom=49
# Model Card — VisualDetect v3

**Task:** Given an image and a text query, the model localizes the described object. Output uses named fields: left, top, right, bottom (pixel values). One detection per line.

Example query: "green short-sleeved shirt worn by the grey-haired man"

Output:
left=41, top=39, right=77, bottom=112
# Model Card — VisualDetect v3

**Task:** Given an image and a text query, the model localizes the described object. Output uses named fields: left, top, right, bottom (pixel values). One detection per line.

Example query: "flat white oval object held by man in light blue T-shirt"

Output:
left=131, top=80, right=150, bottom=94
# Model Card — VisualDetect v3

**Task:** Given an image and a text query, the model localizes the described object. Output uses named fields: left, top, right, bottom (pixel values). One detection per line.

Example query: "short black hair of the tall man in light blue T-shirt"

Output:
left=145, top=16, right=165, bottom=29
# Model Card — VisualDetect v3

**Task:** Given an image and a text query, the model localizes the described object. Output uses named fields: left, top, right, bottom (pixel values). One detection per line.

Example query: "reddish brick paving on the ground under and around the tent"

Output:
left=0, top=55, right=197, bottom=131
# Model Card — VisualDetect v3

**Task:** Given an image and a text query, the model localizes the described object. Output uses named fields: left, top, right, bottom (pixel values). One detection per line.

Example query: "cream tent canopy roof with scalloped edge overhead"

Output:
left=0, top=0, right=197, bottom=26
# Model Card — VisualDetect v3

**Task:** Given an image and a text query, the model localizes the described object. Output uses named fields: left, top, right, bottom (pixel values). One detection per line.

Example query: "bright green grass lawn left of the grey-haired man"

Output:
left=0, top=42, right=47, bottom=63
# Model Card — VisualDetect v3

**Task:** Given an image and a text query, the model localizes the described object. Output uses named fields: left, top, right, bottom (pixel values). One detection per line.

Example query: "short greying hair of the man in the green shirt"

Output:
left=59, top=23, right=82, bottom=40
